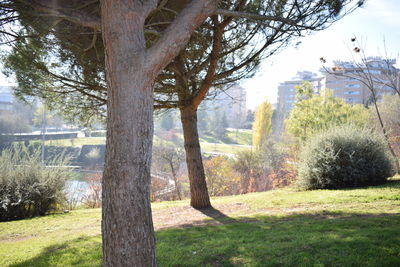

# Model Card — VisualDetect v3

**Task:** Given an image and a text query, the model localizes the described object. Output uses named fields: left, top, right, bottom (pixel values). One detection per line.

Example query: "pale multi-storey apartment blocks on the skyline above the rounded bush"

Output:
left=278, top=57, right=400, bottom=116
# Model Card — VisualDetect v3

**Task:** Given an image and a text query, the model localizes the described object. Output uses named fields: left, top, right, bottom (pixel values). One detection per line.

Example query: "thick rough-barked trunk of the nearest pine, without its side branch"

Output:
left=102, top=0, right=156, bottom=267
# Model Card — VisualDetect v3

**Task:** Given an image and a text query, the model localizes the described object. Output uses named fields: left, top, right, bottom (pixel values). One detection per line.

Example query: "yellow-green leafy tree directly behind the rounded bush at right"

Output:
left=285, top=83, right=369, bottom=141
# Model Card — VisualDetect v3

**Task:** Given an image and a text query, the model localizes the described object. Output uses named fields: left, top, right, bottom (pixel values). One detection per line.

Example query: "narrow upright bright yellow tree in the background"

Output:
left=253, top=101, right=272, bottom=149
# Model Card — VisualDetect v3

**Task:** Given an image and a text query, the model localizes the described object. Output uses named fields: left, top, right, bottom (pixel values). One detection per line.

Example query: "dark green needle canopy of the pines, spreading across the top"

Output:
left=0, top=0, right=362, bottom=122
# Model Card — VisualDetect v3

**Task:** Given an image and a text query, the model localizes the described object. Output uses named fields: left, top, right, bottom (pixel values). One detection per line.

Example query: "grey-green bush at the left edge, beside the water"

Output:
left=0, top=146, right=70, bottom=221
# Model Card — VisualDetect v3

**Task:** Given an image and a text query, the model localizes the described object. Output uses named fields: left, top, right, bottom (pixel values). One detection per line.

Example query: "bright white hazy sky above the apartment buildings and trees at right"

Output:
left=0, top=0, right=400, bottom=109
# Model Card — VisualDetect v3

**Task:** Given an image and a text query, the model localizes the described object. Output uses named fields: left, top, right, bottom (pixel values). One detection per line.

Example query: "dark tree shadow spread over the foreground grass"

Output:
left=12, top=209, right=400, bottom=267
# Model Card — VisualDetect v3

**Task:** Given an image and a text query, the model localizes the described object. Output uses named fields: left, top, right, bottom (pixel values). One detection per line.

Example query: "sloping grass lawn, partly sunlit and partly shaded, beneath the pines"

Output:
left=0, top=177, right=400, bottom=266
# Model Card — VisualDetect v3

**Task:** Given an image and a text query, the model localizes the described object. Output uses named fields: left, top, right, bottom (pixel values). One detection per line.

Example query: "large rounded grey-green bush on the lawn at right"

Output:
left=298, top=126, right=394, bottom=189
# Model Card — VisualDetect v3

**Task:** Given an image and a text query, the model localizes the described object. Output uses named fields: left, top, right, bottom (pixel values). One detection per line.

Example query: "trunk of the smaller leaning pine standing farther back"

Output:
left=180, top=106, right=211, bottom=209
